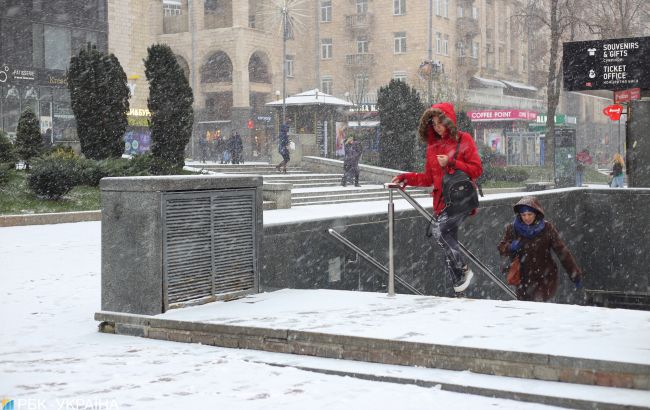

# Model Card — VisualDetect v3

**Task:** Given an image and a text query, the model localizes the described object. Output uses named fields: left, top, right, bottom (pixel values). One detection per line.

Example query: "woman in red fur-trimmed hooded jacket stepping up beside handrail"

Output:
left=392, top=102, right=483, bottom=293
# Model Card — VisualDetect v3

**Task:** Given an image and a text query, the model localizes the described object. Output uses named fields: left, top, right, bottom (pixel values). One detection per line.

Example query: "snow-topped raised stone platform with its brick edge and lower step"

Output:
left=95, top=289, right=650, bottom=408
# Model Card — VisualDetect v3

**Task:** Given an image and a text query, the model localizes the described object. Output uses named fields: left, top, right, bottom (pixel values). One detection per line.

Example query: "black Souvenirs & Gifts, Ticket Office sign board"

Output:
left=562, top=37, right=650, bottom=91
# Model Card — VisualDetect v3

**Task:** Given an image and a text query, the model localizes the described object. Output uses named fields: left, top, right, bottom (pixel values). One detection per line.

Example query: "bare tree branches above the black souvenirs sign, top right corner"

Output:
left=585, top=0, right=650, bottom=39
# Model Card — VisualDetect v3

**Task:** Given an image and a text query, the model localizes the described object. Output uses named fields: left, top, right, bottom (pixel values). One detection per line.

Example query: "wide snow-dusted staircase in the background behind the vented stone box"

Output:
left=190, top=163, right=430, bottom=209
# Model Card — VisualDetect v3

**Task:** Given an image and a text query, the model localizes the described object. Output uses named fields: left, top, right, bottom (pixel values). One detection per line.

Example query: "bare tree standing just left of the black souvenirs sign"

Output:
left=513, top=0, right=589, bottom=164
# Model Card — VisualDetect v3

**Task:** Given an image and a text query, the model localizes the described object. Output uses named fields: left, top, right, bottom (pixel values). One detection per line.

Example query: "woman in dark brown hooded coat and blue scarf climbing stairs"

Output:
left=497, top=196, right=582, bottom=301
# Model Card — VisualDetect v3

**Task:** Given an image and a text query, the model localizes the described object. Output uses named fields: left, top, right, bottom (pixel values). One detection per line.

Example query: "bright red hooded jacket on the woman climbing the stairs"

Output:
left=398, top=102, right=483, bottom=215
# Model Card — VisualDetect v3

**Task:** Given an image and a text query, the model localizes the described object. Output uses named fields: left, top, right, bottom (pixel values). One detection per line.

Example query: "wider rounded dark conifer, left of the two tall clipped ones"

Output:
left=68, top=45, right=129, bottom=159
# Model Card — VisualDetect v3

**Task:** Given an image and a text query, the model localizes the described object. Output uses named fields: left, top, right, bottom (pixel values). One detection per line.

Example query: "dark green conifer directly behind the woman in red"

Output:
left=377, top=79, right=424, bottom=171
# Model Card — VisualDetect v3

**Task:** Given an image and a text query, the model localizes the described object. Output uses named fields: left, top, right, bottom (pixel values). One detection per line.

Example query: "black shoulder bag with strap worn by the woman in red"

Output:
left=442, top=135, right=483, bottom=216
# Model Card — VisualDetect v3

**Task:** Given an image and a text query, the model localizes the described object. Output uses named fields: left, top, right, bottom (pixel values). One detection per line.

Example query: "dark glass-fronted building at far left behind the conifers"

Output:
left=0, top=0, right=108, bottom=145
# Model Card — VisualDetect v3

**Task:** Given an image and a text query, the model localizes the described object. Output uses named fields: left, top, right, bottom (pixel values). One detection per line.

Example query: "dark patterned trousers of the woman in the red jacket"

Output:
left=431, top=212, right=469, bottom=281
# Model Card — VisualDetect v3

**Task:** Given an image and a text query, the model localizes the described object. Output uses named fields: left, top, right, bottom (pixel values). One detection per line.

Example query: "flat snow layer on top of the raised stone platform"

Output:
left=160, top=289, right=650, bottom=365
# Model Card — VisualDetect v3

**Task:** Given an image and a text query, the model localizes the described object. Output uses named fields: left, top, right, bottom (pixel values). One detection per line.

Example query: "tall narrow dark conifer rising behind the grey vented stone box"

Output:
left=144, top=44, right=194, bottom=174
